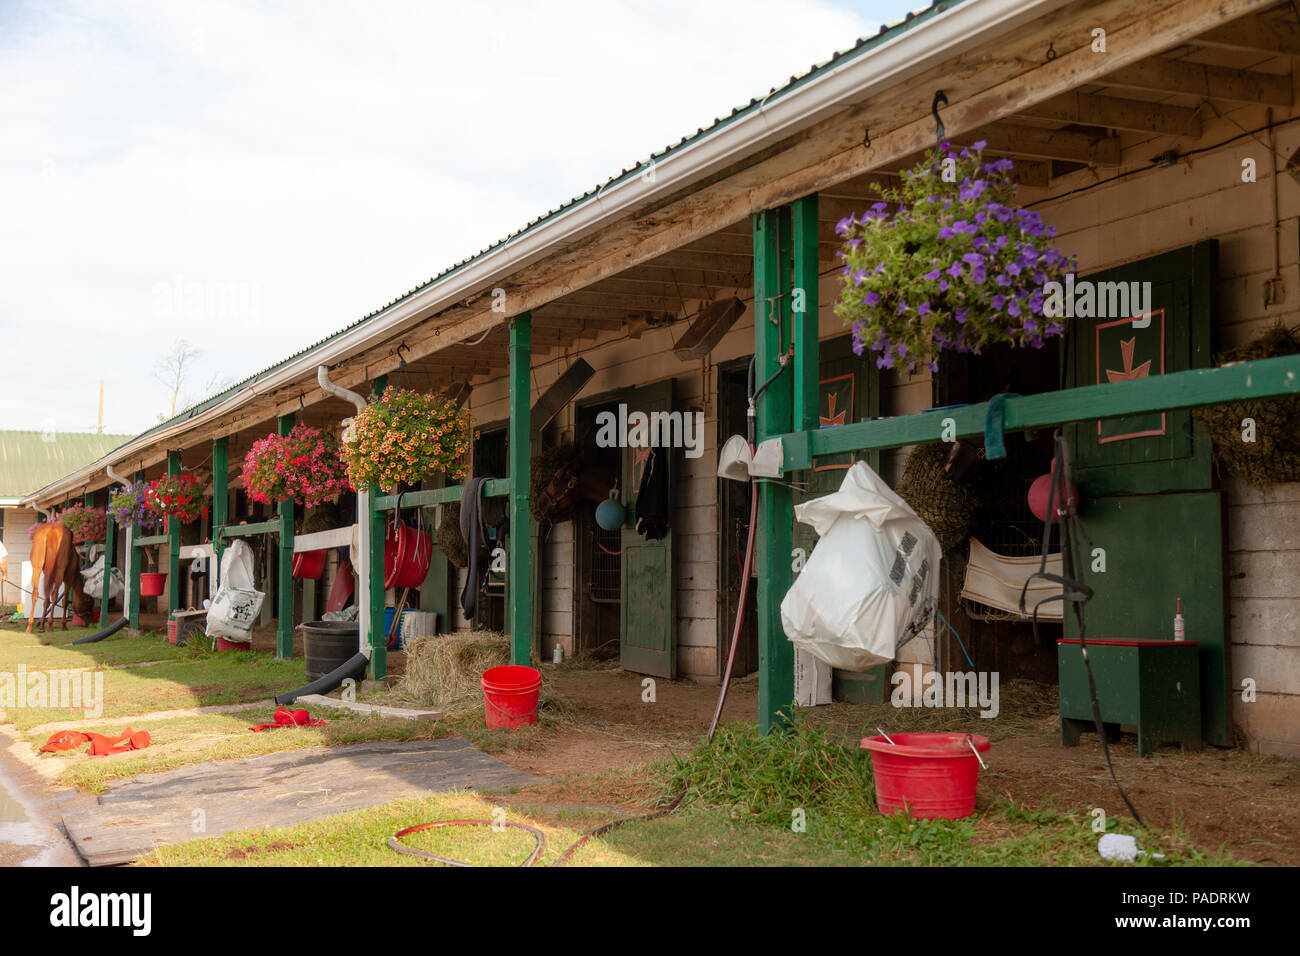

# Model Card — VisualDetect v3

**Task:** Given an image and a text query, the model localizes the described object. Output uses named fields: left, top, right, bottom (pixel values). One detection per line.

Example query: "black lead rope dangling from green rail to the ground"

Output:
left=1021, top=431, right=1147, bottom=826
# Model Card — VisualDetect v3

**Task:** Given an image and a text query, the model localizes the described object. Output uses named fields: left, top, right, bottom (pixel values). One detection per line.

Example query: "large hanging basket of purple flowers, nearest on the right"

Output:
left=835, top=142, right=1074, bottom=372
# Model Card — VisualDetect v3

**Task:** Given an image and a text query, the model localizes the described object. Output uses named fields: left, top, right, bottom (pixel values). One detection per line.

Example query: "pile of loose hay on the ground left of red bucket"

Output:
left=400, top=631, right=510, bottom=713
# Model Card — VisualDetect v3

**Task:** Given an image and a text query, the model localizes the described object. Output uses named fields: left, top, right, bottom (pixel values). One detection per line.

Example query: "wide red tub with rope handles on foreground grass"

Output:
left=862, top=734, right=989, bottom=819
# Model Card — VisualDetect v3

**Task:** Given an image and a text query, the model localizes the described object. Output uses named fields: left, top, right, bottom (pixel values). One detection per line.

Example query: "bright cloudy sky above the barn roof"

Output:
left=0, top=0, right=922, bottom=433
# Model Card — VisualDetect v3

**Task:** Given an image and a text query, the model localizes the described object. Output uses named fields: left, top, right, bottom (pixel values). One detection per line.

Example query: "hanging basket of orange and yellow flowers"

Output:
left=343, top=385, right=469, bottom=490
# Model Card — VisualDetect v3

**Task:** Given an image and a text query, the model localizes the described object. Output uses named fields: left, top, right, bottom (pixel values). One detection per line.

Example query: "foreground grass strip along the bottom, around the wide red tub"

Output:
left=142, top=718, right=1235, bottom=866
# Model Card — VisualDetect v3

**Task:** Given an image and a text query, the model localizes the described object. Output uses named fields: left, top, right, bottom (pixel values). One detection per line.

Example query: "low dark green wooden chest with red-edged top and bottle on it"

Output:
left=1057, top=637, right=1201, bottom=757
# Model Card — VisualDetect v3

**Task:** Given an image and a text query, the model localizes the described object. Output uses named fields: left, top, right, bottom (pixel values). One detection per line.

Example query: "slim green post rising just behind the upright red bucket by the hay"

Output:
left=506, top=312, right=533, bottom=665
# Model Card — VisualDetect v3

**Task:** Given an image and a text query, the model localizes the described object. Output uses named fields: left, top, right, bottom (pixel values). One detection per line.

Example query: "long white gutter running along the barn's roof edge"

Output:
left=25, top=0, right=1070, bottom=502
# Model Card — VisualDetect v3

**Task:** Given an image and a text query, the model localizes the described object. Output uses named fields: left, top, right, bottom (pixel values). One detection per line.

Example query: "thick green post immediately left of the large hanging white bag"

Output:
left=754, top=207, right=795, bottom=734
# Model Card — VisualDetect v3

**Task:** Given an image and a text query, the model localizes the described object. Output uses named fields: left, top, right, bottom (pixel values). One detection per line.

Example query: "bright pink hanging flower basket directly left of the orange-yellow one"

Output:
left=243, top=423, right=351, bottom=507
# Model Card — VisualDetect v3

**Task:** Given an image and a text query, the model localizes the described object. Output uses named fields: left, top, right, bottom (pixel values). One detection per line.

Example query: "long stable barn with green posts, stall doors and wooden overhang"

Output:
left=27, top=0, right=1300, bottom=757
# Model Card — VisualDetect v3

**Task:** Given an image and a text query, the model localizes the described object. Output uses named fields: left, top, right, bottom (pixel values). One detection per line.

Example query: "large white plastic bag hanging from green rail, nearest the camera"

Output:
left=781, top=462, right=943, bottom=671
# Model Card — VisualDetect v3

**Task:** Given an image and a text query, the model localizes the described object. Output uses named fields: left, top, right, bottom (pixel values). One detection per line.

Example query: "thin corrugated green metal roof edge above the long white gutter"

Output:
left=31, top=0, right=969, bottom=478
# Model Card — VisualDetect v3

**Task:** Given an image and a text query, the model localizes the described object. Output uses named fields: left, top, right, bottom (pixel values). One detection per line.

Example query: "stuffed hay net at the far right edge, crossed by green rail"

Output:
left=1192, top=323, right=1300, bottom=486
